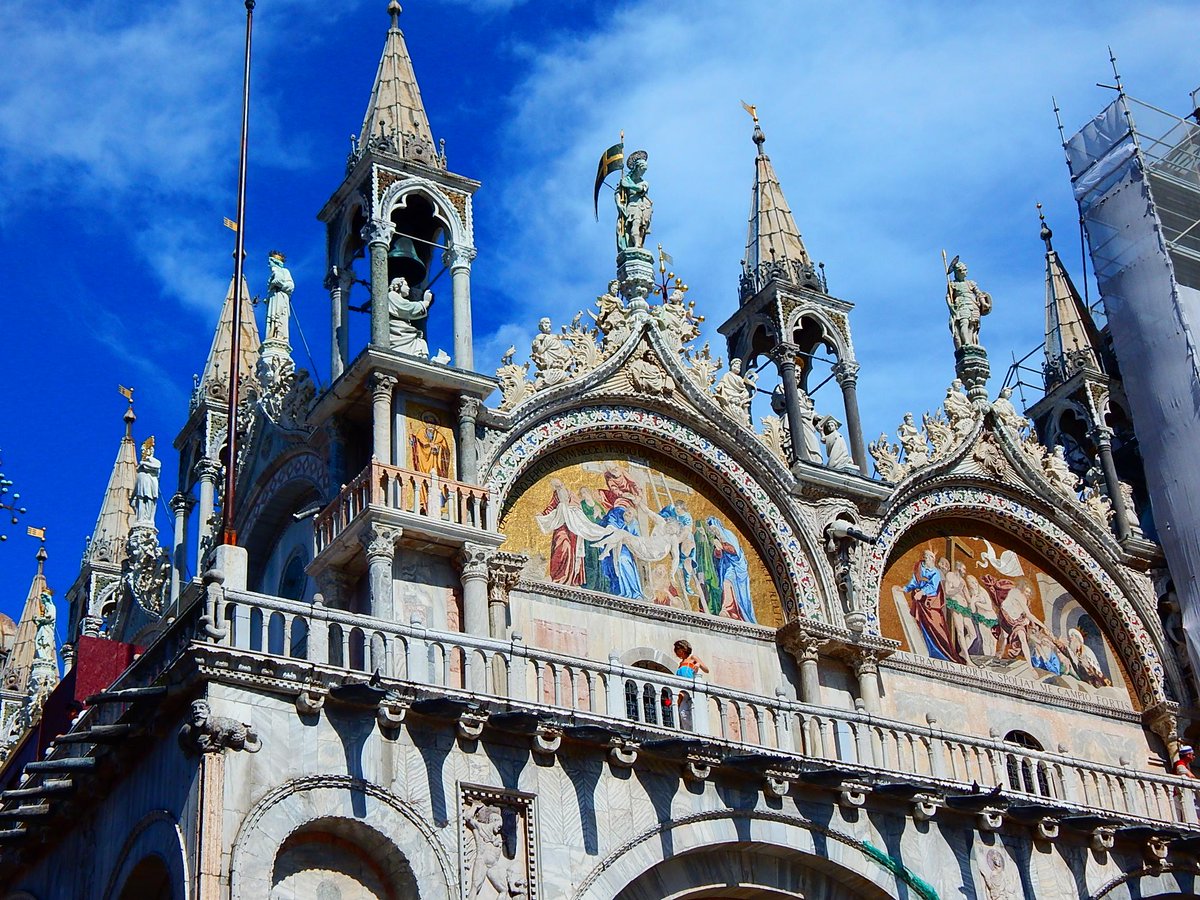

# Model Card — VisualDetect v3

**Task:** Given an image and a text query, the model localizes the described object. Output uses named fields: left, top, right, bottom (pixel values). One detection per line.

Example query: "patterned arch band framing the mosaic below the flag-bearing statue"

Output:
left=487, top=406, right=835, bottom=622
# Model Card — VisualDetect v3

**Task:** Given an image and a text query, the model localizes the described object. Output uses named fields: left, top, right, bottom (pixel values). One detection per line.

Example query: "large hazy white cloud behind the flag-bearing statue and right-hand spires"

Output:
left=476, top=0, right=1193, bottom=448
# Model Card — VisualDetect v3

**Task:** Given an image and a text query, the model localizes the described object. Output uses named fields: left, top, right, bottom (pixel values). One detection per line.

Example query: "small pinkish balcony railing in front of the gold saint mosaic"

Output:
left=314, top=461, right=491, bottom=553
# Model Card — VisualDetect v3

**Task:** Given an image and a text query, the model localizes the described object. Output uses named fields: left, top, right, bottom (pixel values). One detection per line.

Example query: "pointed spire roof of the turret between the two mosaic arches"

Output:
left=742, top=107, right=824, bottom=300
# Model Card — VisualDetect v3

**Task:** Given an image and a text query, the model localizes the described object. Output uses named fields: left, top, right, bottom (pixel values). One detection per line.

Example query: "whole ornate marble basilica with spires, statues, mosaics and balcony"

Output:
left=0, top=2, right=1200, bottom=900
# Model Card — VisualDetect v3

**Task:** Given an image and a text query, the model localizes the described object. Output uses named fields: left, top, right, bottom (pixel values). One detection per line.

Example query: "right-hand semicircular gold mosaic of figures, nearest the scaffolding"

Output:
left=883, top=535, right=1129, bottom=700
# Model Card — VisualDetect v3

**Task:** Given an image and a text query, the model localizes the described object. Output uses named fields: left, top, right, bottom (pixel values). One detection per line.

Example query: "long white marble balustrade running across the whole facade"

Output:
left=208, top=592, right=1200, bottom=828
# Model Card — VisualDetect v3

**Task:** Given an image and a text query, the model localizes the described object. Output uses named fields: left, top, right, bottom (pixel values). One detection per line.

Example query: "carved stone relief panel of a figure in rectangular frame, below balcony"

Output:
left=458, top=785, right=540, bottom=900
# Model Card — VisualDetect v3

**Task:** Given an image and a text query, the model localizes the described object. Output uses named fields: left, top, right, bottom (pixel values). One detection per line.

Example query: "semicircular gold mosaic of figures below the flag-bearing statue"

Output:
left=500, top=451, right=781, bottom=626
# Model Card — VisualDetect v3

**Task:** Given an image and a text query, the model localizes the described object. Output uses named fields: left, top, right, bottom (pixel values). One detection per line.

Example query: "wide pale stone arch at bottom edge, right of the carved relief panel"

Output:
left=571, top=810, right=907, bottom=900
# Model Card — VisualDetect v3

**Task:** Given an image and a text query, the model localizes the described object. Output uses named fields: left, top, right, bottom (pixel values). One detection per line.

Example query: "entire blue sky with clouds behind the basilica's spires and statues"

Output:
left=0, top=0, right=1200, bottom=616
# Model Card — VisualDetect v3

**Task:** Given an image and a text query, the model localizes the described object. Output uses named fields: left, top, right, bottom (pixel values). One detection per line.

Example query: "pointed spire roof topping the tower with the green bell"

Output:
left=359, top=0, right=433, bottom=162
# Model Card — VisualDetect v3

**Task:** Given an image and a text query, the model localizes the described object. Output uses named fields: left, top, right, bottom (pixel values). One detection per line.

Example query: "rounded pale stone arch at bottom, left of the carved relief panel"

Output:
left=229, top=775, right=458, bottom=900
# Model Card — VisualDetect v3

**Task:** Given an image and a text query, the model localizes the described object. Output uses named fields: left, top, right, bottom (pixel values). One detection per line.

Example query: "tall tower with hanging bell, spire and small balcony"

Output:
left=305, top=0, right=503, bottom=635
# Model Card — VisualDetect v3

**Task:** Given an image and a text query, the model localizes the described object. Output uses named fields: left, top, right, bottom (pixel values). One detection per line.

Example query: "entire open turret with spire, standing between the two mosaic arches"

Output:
left=719, top=107, right=870, bottom=475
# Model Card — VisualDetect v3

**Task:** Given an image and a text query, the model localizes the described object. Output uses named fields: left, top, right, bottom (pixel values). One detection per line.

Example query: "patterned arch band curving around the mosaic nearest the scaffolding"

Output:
left=863, top=485, right=1166, bottom=708
